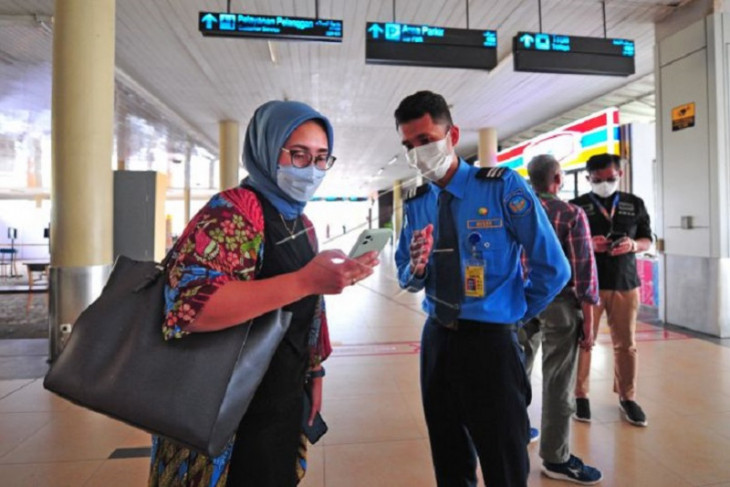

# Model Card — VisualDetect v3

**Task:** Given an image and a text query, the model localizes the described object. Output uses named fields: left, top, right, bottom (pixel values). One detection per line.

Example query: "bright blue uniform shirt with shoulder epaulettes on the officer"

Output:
left=395, top=160, right=570, bottom=324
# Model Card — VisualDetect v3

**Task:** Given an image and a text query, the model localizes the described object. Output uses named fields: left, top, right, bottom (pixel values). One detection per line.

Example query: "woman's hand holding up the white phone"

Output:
left=299, top=250, right=380, bottom=294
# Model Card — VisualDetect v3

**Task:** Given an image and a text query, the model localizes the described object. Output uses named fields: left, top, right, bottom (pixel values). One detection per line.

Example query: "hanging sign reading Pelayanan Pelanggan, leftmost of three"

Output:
left=198, top=12, right=342, bottom=42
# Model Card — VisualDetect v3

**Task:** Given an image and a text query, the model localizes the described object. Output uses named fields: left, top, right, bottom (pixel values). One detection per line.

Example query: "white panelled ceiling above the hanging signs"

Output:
left=0, top=0, right=692, bottom=195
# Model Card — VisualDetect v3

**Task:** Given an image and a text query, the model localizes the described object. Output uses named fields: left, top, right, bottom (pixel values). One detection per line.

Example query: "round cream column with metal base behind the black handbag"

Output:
left=49, top=0, right=115, bottom=360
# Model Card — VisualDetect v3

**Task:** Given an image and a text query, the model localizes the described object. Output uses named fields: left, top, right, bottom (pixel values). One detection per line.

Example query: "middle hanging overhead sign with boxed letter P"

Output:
left=365, top=22, right=497, bottom=70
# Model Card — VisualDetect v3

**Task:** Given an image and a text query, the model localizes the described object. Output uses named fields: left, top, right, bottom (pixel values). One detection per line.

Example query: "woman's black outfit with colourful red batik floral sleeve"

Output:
left=149, top=187, right=331, bottom=487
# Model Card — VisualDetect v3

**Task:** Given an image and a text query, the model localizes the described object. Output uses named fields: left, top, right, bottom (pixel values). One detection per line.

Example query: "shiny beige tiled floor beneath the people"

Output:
left=0, top=251, right=730, bottom=487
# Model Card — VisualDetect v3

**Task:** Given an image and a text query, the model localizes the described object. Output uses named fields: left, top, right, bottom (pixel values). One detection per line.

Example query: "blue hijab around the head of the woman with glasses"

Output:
left=243, top=101, right=334, bottom=220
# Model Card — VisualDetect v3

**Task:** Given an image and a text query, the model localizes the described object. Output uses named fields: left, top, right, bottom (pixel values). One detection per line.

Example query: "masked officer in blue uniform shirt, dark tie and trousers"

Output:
left=395, top=91, right=570, bottom=487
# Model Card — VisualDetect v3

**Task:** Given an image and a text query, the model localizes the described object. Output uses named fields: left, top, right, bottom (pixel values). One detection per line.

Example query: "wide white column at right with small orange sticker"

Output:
left=655, top=1, right=730, bottom=337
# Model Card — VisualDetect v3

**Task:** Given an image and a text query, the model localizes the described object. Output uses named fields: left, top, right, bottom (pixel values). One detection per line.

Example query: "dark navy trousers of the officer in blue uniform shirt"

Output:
left=421, top=319, right=531, bottom=487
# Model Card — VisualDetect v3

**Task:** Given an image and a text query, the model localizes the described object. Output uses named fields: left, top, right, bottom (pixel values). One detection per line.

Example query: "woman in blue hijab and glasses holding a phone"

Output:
left=149, top=101, right=378, bottom=487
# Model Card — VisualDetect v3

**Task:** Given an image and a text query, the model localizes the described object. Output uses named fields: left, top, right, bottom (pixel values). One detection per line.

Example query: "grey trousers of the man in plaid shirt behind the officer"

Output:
left=518, top=294, right=583, bottom=463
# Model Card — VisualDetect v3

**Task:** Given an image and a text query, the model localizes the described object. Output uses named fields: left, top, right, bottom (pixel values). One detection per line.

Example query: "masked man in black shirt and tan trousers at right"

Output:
left=572, top=154, right=652, bottom=426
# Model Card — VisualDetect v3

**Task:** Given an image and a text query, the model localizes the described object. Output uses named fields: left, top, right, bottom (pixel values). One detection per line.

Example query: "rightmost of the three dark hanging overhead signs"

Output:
left=512, top=32, right=636, bottom=76
